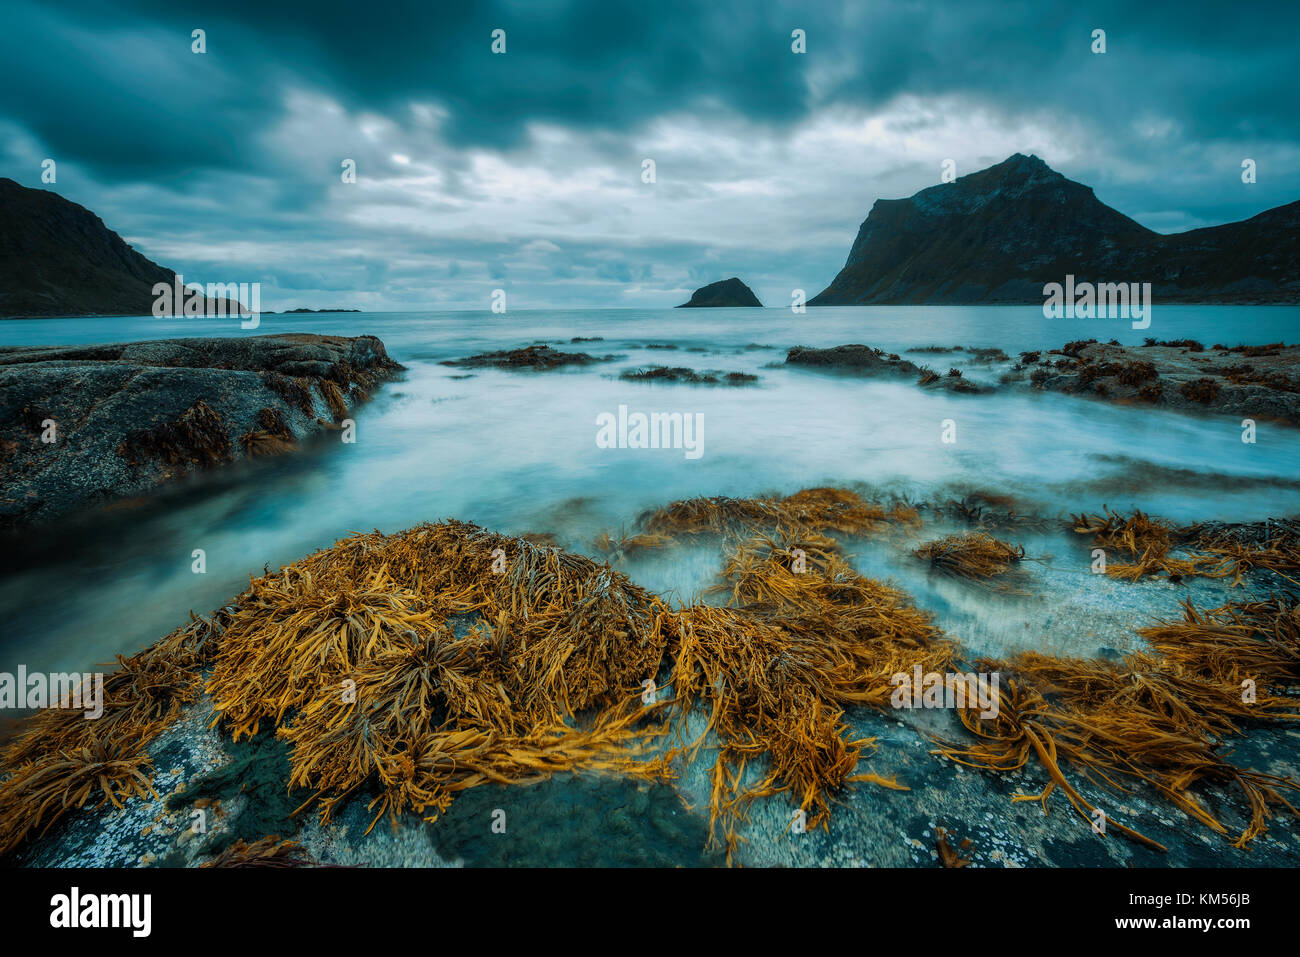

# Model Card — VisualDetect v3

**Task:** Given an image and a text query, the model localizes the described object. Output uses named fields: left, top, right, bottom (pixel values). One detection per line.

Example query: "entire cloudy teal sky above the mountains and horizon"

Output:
left=0, top=0, right=1300, bottom=309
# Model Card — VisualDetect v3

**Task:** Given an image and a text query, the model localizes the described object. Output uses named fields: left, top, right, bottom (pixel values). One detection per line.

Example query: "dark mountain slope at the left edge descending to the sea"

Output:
left=0, top=178, right=236, bottom=317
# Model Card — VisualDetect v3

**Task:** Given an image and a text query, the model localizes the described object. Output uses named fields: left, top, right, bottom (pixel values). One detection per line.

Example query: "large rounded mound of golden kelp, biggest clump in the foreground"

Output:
left=208, top=523, right=668, bottom=826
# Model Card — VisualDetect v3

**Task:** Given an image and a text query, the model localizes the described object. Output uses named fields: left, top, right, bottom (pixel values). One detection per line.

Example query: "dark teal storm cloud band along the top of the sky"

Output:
left=10, top=0, right=1300, bottom=170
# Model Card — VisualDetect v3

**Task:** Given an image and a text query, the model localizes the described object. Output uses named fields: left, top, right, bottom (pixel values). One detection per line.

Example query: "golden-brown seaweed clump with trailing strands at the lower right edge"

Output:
left=936, top=599, right=1300, bottom=850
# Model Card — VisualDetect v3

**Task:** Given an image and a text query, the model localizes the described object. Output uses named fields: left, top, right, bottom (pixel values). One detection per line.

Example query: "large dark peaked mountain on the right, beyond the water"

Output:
left=809, top=153, right=1300, bottom=306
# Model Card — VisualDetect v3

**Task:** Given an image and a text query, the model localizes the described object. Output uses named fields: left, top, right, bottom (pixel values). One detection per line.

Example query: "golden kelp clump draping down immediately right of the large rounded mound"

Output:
left=671, top=536, right=954, bottom=859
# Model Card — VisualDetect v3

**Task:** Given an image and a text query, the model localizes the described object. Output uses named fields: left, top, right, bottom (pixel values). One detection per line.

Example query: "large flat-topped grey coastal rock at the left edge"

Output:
left=0, top=334, right=402, bottom=527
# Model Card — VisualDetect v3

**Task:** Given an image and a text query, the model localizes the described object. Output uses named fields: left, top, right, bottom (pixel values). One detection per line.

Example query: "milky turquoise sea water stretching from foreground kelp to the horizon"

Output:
left=0, top=304, right=1300, bottom=671
